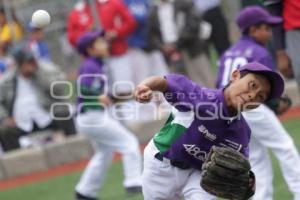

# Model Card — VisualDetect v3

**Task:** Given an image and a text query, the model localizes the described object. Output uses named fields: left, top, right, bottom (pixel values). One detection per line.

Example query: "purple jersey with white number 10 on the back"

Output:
left=217, top=36, right=274, bottom=88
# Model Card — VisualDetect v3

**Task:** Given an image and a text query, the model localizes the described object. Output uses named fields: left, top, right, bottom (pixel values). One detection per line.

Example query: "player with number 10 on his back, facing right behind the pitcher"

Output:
left=217, top=6, right=300, bottom=200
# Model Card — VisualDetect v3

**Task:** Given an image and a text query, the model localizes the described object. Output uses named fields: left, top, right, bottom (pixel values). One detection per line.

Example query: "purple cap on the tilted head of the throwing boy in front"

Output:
left=238, top=62, right=284, bottom=99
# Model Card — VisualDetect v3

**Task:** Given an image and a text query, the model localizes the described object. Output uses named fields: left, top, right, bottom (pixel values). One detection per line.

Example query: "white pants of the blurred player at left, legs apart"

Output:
left=76, top=111, right=142, bottom=197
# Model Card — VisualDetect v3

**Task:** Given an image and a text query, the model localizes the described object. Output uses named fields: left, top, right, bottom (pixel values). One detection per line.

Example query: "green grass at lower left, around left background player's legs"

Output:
left=0, top=162, right=142, bottom=200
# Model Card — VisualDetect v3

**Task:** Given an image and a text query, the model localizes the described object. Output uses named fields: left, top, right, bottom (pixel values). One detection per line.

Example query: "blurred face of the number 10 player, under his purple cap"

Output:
left=250, top=24, right=272, bottom=45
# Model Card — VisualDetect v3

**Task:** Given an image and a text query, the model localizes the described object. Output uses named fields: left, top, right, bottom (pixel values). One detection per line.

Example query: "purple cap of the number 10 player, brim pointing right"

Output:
left=236, top=6, right=282, bottom=32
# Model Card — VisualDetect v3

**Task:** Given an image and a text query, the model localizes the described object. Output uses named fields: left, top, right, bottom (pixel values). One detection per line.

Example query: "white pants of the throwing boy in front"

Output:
left=142, top=140, right=216, bottom=200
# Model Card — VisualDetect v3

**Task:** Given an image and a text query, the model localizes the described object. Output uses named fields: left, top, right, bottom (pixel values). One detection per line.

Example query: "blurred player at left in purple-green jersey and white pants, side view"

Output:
left=76, top=31, right=142, bottom=200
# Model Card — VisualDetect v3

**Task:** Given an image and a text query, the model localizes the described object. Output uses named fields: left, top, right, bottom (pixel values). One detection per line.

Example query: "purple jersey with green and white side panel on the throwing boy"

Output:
left=153, top=74, right=250, bottom=170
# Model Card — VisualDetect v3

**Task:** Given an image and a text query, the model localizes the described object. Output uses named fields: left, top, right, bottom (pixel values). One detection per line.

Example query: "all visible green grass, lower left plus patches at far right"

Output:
left=0, top=119, right=300, bottom=200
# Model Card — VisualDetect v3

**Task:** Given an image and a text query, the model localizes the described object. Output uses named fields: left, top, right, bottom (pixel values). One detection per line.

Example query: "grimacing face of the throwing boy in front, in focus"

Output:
left=225, top=70, right=271, bottom=110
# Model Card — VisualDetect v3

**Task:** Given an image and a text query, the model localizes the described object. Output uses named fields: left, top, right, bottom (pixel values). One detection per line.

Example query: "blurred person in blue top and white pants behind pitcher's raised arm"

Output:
left=120, top=0, right=168, bottom=123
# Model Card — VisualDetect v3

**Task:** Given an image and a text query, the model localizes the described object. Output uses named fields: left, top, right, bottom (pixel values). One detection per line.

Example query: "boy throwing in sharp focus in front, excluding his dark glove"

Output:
left=135, top=62, right=284, bottom=200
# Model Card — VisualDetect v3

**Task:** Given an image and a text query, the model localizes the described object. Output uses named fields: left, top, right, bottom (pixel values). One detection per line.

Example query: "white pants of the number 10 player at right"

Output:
left=243, top=105, right=300, bottom=200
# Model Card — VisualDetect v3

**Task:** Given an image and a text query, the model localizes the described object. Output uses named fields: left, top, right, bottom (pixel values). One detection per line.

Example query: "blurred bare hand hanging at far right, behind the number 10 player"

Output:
left=276, top=50, right=294, bottom=78
